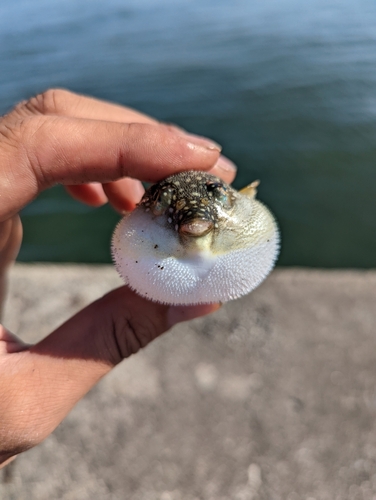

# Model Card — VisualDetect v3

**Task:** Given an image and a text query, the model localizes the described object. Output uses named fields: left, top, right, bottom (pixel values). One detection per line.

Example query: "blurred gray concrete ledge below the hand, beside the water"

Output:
left=0, top=266, right=376, bottom=500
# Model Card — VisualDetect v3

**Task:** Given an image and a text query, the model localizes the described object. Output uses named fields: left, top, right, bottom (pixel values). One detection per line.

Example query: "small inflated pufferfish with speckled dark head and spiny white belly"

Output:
left=112, top=171, right=279, bottom=304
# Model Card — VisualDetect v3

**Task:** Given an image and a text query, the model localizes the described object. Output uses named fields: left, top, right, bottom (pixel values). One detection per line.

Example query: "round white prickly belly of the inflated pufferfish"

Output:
left=112, top=210, right=279, bottom=304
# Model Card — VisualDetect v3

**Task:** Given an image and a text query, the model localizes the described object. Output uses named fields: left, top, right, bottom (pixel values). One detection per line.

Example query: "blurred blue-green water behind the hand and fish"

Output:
left=0, top=0, right=376, bottom=268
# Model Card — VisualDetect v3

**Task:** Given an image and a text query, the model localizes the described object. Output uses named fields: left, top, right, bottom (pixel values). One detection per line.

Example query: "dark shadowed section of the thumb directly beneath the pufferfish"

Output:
left=31, top=286, right=220, bottom=368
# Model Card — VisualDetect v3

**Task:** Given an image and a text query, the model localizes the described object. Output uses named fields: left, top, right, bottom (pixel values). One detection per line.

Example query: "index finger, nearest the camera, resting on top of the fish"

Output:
left=0, top=116, right=220, bottom=222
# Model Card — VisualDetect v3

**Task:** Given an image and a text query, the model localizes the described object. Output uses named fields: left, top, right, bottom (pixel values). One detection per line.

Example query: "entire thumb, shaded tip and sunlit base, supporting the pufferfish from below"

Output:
left=0, top=287, right=219, bottom=456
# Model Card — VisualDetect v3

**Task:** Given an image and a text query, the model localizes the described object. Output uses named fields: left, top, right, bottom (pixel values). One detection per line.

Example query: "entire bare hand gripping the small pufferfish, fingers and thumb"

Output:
left=0, top=89, right=235, bottom=467
